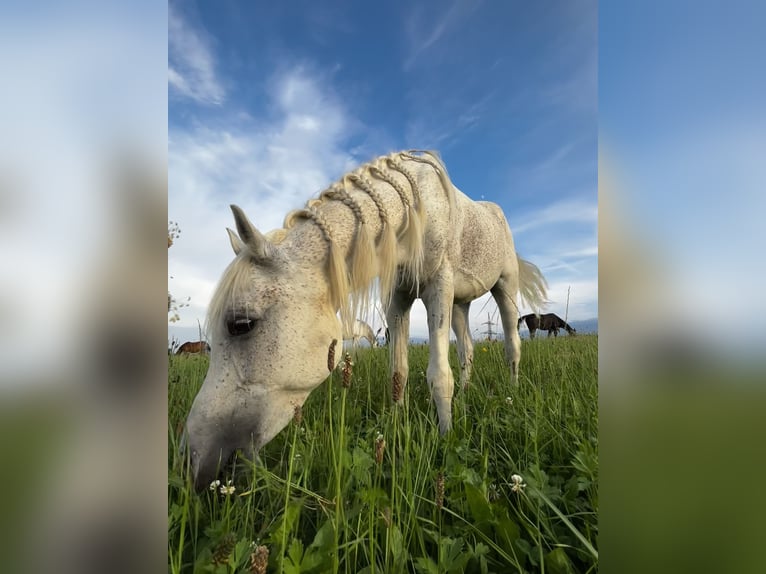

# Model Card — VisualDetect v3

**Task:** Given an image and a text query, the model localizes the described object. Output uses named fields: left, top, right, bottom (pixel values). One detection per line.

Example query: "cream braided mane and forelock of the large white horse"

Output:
left=207, top=150, right=455, bottom=338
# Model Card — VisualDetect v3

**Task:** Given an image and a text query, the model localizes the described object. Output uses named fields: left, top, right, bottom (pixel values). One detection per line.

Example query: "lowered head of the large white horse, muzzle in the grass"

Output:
left=184, top=207, right=342, bottom=488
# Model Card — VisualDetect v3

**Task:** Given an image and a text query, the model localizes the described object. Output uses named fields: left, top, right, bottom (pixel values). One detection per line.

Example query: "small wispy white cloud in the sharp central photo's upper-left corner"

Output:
left=168, top=3, right=226, bottom=105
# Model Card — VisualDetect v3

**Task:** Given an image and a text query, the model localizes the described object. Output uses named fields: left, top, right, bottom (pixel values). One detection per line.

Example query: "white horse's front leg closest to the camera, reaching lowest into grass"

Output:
left=422, top=266, right=455, bottom=434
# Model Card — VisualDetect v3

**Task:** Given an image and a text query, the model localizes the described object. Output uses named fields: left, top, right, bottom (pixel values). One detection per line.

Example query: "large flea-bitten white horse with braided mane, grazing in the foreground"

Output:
left=182, top=151, right=547, bottom=488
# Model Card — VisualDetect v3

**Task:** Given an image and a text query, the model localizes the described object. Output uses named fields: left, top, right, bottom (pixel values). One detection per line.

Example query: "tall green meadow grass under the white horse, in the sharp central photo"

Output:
left=168, top=335, right=598, bottom=574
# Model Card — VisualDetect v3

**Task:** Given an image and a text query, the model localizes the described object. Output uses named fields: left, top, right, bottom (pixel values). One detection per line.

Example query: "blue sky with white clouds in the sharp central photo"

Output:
left=168, top=1, right=598, bottom=338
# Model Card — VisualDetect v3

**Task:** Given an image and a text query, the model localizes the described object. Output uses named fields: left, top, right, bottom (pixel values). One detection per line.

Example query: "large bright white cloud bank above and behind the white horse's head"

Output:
left=168, top=68, right=360, bottom=331
